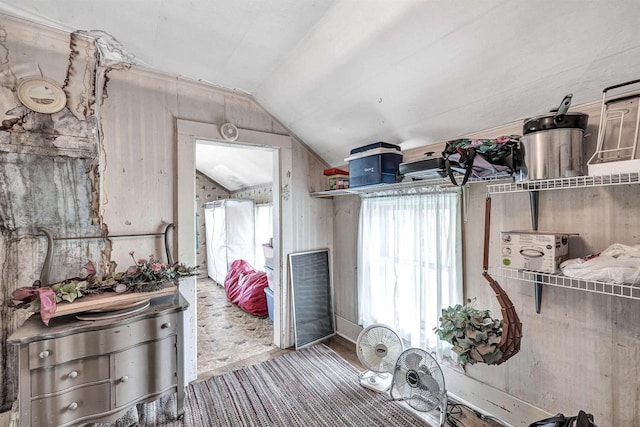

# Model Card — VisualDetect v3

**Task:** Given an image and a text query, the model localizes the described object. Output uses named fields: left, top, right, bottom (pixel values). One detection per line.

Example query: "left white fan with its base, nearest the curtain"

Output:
left=356, top=323, right=403, bottom=393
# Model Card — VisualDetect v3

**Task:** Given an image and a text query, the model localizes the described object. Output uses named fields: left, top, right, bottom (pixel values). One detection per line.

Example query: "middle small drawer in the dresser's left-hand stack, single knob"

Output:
left=31, top=355, right=109, bottom=396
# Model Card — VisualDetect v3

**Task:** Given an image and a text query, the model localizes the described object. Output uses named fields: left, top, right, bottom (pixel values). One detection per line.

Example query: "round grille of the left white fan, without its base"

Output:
left=356, top=324, right=402, bottom=372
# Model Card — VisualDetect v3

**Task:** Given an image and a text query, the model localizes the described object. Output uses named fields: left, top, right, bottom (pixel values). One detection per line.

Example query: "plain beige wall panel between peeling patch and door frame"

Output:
left=100, top=68, right=286, bottom=274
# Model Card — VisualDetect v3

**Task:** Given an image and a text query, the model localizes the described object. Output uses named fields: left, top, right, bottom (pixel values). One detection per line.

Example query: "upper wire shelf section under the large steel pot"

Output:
left=487, top=172, right=640, bottom=194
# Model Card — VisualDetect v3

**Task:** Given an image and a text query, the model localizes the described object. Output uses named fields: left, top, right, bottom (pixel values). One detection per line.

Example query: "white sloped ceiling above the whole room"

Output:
left=0, top=0, right=640, bottom=166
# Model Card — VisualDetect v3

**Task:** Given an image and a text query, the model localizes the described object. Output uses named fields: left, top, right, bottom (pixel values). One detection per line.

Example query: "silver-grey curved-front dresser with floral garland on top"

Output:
left=7, top=293, right=188, bottom=427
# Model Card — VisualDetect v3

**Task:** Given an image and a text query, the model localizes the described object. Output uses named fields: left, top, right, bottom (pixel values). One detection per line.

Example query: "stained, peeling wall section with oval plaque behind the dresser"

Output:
left=0, top=14, right=104, bottom=410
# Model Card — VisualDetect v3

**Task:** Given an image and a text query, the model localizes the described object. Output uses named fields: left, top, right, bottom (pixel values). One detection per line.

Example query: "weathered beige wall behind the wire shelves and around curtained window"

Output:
left=334, top=101, right=640, bottom=427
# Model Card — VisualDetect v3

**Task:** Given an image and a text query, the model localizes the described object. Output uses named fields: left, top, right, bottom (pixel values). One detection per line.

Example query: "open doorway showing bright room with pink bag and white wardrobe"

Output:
left=195, top=138, right=278, bottom=377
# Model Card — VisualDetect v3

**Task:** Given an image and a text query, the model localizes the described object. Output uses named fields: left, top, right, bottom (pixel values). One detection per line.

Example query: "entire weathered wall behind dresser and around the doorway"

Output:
left=0, top=12, right=332, bottom=409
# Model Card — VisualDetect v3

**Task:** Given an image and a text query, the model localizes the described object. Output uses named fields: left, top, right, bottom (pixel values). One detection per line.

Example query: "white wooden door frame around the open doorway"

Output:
left=175, top=120, right=293, bottom=383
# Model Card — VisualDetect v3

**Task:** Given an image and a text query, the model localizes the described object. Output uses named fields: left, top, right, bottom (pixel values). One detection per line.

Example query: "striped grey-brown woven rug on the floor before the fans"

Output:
left=184, top=345, right=428, bottom=427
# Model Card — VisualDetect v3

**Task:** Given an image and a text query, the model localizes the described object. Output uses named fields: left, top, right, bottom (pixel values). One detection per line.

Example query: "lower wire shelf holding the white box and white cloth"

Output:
left=489, top=267, right=640, bottom=300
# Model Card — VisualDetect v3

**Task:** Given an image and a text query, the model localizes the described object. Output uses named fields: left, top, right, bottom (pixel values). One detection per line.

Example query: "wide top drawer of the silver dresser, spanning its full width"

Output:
left=29, top=313, right=177, bottom=369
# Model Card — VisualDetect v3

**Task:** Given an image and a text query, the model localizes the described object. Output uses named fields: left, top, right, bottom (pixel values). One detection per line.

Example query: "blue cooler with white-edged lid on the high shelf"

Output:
left=344, top=143, right=402, bottom=187
